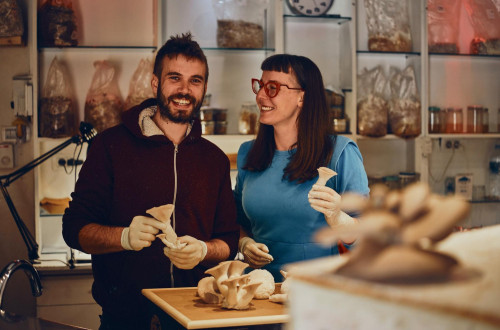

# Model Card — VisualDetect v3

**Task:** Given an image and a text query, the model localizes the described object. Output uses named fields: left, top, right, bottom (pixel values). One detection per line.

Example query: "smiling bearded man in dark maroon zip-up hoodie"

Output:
left=63, top=33, right=239, bottom=329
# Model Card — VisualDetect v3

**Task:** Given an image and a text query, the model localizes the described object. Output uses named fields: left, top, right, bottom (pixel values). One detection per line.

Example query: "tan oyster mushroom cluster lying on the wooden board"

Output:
left=197, top=260, right=274, bottom=310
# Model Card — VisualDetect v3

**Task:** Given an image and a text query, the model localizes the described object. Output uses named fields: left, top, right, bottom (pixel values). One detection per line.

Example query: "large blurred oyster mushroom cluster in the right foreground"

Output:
left=316, top=182, right=470, bottom=283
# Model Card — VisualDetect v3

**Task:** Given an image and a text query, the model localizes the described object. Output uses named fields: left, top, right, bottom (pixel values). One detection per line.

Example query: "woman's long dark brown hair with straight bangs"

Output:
left=243, top=54, right=334, bottom=183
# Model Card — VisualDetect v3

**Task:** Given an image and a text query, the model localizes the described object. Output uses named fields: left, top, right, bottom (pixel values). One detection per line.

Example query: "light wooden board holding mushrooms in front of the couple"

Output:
left=142, top=284, right=289, bottom=329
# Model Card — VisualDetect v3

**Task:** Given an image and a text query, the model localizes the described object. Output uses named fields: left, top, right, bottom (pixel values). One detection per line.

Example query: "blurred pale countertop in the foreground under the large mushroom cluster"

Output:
left=287, top=225, right=500, bottom=327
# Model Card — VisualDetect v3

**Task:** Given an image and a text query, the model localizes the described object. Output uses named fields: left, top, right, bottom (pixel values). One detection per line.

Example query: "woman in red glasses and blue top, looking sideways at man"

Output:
left=234, top=54, right=369, bottom=281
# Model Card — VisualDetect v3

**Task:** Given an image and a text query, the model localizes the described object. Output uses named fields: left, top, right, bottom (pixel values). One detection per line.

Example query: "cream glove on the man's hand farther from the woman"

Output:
left=121, top=215, right=166, bottom=251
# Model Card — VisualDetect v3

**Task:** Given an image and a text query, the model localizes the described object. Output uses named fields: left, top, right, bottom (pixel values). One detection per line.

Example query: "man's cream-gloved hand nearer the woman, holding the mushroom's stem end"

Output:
left=163, top=235, right=207, bottom=269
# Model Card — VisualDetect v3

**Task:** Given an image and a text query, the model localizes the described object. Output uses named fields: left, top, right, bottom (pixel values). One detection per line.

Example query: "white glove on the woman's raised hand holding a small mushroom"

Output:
left=307, top=184, right=355, bottom=228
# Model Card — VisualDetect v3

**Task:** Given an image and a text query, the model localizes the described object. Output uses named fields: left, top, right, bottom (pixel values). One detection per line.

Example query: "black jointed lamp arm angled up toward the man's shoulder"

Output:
left=0, top=122, right=97, bottom=263
